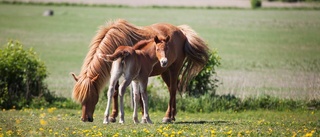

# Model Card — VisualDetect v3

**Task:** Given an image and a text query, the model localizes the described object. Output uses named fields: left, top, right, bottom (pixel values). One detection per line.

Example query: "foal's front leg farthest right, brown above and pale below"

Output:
left=140, top=77, right=153, bottom=124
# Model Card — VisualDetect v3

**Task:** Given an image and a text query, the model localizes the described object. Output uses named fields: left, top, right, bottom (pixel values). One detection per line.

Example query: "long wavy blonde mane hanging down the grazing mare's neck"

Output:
left=72, top=19, right=150, bottom=103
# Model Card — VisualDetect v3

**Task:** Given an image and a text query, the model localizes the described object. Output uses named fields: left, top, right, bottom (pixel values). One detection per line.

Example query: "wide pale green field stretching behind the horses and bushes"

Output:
left=0, top=4, right=320, bottom=100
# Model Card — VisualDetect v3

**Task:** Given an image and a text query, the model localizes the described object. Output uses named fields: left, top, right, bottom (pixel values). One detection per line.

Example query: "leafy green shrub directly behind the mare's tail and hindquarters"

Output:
left=187, top=50, right=221, bottom=97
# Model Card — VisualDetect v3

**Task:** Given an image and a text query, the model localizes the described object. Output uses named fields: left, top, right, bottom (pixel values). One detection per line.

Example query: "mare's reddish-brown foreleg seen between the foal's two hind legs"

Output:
left=109, top=81, right=119, bottom=123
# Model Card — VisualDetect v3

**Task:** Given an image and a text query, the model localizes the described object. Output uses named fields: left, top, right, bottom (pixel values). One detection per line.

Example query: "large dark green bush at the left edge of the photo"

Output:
left=0, top=41, right=53, bottom=109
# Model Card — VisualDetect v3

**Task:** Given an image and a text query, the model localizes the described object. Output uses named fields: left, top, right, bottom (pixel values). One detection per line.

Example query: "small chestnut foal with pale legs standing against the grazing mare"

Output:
left=99, top=36, right=170, bottom=124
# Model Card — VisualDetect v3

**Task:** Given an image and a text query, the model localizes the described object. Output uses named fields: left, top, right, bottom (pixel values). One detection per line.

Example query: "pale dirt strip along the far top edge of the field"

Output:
left=8, top=0, right=320, bottom=8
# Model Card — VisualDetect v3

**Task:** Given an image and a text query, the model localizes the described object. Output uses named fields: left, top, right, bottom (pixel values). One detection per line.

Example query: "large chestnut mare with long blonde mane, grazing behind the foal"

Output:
left=72, top=20, right=209, bottom=122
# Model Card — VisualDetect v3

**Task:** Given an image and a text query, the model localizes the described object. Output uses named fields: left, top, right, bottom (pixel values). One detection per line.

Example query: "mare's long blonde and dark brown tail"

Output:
left=178, top=25, right=209, bottom=91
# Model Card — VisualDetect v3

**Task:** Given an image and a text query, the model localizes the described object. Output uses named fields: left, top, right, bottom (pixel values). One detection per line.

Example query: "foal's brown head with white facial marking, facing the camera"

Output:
left=154, top=36, right=170, bottom=67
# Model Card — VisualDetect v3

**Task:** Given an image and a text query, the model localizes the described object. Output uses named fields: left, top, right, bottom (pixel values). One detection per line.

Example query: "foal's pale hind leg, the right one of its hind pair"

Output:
left=119, top=79, right=132, bottom=124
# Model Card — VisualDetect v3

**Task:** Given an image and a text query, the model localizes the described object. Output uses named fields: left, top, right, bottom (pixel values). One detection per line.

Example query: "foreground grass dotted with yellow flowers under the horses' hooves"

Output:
left=0, top=108, right=320, bottom=136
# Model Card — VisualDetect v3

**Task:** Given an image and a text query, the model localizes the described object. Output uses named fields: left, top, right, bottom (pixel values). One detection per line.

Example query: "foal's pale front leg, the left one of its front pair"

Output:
left=132, top=81, right=141, bottom=124
